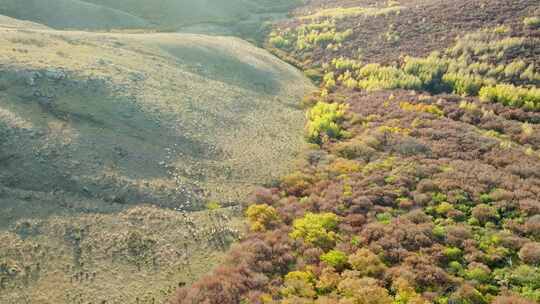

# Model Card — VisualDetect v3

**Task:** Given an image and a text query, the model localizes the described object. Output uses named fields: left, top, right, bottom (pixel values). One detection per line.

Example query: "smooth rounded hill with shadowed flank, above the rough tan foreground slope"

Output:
left=0, top=25, right=309, bottom=207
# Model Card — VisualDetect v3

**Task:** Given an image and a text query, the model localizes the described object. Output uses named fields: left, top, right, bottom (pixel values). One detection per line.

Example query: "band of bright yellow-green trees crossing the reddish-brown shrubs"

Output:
left=318, top=27, right=540, bottom=111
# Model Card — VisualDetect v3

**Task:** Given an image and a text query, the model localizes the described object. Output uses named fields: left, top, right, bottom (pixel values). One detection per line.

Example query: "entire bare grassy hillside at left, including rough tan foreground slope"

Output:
left=0, top=18, right=312, bottom=303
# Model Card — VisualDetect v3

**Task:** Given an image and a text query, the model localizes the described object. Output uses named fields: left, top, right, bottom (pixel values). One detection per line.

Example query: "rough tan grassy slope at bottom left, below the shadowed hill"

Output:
left=0, top=204, right=242, bottom=304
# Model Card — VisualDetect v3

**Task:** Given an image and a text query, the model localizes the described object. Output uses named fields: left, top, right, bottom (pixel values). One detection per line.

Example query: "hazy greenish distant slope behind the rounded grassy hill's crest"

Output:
left=0, top=0, right=300, bottom=36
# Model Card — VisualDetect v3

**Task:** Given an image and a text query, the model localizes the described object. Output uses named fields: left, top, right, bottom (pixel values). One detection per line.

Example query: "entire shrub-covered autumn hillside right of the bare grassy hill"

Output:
left=171, top=0, right=540, bottom=304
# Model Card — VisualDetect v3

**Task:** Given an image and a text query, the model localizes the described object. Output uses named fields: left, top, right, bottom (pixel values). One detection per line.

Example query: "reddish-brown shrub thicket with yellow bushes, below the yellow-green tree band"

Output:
left=173, top=85, right=540, bottom=304
